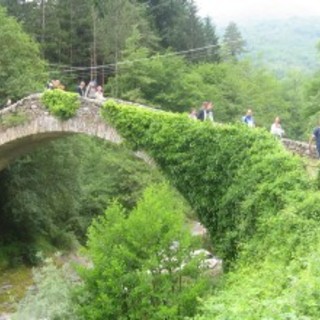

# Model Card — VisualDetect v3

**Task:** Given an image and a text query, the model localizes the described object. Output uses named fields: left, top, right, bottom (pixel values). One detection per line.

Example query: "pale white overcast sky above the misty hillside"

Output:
left=195, top=0, right=320, bottom=24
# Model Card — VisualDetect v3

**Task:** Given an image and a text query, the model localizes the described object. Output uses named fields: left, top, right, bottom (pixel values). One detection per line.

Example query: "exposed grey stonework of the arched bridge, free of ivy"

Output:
left=0, top=94, right=316, bottom=171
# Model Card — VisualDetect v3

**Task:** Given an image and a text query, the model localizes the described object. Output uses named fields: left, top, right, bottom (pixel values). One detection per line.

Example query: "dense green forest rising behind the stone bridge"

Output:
left=0, top=0, right=319, bottom=139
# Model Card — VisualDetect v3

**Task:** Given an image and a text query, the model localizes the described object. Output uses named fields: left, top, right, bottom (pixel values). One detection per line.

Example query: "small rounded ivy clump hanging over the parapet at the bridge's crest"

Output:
left=41, top=89, right=80, bottom=120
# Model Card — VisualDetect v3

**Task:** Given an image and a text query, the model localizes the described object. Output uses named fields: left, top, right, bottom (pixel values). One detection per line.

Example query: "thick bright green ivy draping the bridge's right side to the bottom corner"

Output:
left=103, top=102, right=320, bottom=320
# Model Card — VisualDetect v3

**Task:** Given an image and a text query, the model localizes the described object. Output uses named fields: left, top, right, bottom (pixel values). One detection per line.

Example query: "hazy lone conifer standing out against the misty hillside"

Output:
left=222, top=22, right=245, bottom=61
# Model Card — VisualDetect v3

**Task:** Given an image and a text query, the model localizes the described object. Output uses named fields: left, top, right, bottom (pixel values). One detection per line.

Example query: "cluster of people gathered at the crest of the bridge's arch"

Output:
left=47, top=80, right=104, bottom=100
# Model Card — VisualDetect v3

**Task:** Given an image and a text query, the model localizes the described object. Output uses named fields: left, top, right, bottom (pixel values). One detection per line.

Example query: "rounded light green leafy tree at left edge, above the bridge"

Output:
left=0, top=7, right=47, bottom=105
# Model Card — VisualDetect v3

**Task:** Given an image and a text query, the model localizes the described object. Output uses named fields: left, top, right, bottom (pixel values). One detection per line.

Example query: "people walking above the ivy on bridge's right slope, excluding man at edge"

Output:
left=189, top=101, right=284, bottom=139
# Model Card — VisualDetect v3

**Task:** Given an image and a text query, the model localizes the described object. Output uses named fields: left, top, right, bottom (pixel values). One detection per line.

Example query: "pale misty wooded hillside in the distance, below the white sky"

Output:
left=238, top=17, right=320, bottom=75
